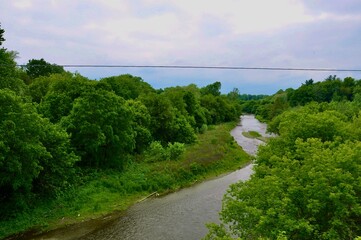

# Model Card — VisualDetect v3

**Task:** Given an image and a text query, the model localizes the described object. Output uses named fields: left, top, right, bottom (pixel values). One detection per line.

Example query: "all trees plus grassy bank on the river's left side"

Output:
left=0, top=24, right=250, bottom=238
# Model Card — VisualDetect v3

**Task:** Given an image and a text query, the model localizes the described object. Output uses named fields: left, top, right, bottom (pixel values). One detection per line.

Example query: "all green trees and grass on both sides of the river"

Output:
left=0, top=21, right=361, bottom=240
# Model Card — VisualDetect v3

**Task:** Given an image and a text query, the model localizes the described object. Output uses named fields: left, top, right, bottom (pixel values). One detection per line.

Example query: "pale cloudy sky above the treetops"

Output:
left=0, top=0, right=361, bottom=94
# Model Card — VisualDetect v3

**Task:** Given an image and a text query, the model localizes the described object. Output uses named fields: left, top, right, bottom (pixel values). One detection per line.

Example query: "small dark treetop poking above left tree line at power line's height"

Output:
left=25, top=58, right=65, bottom=79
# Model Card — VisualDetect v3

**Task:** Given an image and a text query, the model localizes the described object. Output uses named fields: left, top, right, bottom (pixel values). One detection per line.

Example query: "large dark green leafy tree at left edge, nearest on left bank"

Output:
left=0, top=89, right=78, bottom=215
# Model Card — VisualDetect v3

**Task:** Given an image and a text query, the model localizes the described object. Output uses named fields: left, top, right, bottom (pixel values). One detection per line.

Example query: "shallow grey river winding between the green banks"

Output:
left=81, top=115, right=269, bottom=240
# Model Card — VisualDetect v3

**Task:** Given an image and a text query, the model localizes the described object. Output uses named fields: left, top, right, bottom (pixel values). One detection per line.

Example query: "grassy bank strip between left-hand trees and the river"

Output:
left=0, top=123, right=250, bottom=238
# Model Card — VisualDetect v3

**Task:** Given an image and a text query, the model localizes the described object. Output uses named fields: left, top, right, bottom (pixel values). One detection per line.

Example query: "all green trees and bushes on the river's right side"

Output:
left=205, top=77, right=361, bottom=239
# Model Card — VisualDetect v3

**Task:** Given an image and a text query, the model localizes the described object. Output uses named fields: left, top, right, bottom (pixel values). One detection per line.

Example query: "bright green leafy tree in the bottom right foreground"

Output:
left=207, top=139, right=361, bottom=239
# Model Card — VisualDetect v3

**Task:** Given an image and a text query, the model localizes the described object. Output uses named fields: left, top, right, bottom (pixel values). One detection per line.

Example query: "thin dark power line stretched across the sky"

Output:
left=9, top=64, right=361, bottom=72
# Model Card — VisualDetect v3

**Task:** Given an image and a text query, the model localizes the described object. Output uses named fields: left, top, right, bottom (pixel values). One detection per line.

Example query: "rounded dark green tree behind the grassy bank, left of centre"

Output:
left=61, top=90, right=135, bottom=169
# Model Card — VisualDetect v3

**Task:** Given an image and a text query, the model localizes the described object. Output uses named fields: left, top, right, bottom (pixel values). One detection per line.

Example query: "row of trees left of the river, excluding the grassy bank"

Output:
left=0, top=24, right=241, bottom=218
